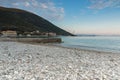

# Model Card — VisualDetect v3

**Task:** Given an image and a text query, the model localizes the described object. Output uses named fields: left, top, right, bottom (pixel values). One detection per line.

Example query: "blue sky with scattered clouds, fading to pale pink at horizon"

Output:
left=0, top=0, right=120, bottom=35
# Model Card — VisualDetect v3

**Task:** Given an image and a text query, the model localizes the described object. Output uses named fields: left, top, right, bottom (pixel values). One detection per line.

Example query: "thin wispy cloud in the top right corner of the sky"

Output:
left=88, top=0, right=120, bottom=9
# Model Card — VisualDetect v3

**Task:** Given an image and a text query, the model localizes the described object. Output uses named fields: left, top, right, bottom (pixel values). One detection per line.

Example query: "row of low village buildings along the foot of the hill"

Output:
left=0, top=30, right=57, bottom=37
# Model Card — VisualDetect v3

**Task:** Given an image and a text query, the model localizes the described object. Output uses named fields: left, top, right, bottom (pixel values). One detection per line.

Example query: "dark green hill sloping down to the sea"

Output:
left=0, top=7, right=73, bottom=36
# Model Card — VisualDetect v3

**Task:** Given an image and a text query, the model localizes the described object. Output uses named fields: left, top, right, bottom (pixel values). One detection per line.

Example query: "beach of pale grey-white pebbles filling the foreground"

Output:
left=0, top=41, right=120, bottom=80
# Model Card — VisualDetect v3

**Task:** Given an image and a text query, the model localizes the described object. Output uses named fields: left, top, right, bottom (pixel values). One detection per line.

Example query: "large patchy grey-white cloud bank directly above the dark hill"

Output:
left=0, top=0, right=64, bottom=20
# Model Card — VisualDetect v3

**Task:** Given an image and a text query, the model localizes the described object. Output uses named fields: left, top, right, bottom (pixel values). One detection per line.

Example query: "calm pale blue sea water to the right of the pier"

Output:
left=56, top=36, right=120, bottom=53
